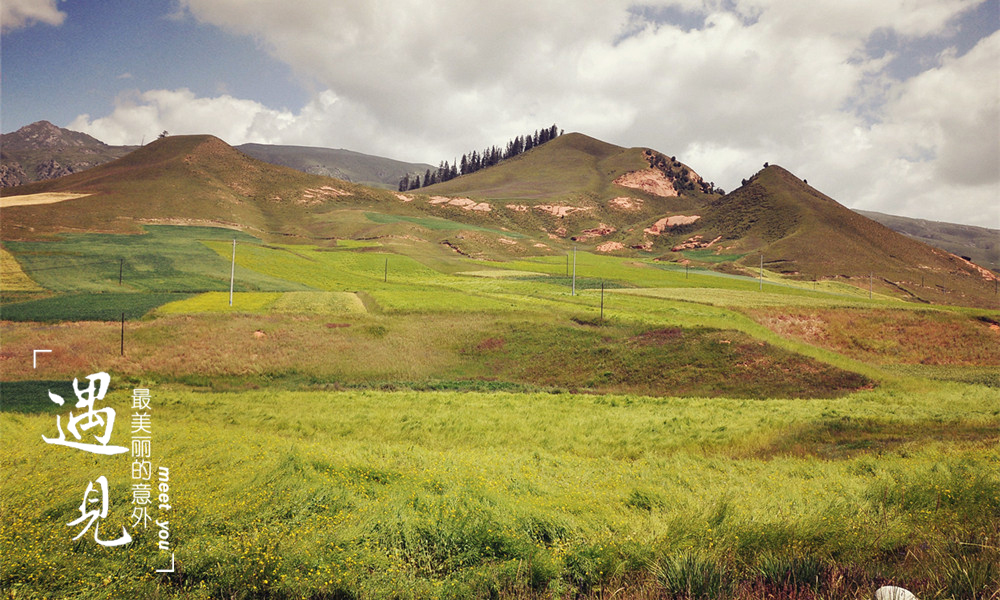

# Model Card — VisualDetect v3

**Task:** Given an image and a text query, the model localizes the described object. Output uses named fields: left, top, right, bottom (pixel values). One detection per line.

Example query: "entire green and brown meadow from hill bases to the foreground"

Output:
left=0, top=219, right=1000, bottom=600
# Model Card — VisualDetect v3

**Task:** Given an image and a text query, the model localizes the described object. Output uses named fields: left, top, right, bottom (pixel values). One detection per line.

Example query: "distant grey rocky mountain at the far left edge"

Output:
left=0, top=121, right=135, bottom=187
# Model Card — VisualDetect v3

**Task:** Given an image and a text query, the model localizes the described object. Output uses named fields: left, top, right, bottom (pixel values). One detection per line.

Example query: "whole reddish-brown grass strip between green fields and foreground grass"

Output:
left=3, top=312, right=873, bottom=398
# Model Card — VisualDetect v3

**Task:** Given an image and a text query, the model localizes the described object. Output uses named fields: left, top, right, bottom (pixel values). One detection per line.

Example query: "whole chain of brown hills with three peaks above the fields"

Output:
left=0, top=134, right=996, bottom=306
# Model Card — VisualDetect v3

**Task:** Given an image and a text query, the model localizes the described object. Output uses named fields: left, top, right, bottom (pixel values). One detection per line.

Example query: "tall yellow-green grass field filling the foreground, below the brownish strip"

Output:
left=0, top=385, right=1000, bottom=598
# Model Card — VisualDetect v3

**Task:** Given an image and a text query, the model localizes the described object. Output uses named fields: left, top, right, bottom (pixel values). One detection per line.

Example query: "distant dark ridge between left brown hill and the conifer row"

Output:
left=236, top=144, right=436, bottom=190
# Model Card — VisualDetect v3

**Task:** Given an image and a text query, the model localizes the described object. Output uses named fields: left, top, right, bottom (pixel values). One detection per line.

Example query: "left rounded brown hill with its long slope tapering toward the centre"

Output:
left=0, top=135, right=561, bottom=261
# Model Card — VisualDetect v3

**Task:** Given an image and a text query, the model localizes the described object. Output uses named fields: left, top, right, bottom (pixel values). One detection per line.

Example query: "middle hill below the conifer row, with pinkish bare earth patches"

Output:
left=420, top=133, right=717, bottom=252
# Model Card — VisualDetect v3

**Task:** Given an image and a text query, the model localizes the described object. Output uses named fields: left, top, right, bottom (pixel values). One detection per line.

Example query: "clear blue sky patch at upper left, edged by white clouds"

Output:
left=0, top=0, right=309, bottom=132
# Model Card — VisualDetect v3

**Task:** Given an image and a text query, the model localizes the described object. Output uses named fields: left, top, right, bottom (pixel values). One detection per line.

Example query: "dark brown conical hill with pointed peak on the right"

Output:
left=692, top=165, right=995, bottom=302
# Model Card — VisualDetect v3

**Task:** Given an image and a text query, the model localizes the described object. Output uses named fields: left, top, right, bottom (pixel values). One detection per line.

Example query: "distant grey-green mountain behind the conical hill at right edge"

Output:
left=854, top=210, right=1000, bottom=272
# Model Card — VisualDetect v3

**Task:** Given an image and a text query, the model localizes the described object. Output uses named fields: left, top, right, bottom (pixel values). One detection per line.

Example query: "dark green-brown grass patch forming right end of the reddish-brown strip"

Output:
left=454, top=323, right=870, bottom=398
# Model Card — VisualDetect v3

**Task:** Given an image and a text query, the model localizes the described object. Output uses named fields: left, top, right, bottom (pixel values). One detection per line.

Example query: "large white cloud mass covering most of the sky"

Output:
left=72, top=0, right=1000, bottom=227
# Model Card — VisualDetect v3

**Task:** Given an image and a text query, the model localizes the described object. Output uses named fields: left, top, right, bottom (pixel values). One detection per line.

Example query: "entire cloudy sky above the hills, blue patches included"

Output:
left=0, top=0, right=1000, bottom=228
